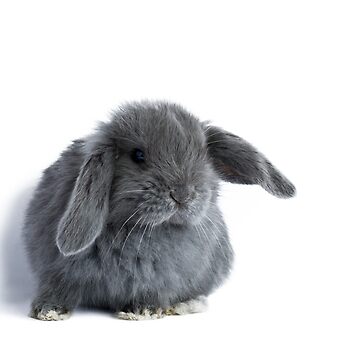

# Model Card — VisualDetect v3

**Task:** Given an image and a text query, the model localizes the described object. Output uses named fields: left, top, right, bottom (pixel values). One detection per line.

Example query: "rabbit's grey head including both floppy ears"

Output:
left=57, top=102, right=295, bottom=255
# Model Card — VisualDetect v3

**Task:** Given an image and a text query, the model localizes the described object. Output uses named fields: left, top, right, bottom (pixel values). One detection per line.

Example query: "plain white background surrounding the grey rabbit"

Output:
left=0, top=0, right=360, bottom=360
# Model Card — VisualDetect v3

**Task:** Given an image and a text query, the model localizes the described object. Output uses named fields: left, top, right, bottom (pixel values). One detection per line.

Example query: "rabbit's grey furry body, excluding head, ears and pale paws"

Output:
left=25, top=142, right=232, bottom=310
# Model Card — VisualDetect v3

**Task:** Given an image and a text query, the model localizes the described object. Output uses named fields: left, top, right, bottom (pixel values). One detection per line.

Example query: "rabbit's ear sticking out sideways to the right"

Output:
left=205, top=126, right=295, bottom=198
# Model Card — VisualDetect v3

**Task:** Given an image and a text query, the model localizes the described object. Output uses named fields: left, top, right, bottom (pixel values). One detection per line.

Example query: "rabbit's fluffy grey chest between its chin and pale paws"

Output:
left=79, top=224, right=231, bottom=308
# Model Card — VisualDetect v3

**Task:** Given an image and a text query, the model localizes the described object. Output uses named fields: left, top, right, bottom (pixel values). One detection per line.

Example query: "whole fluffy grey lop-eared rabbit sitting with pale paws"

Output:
left=23, top=101, right=295, bottom=320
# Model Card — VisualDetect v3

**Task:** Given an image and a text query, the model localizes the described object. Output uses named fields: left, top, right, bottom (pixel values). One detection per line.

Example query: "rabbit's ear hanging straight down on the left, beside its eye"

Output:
left=56, top=151, right=113, bottom=256
